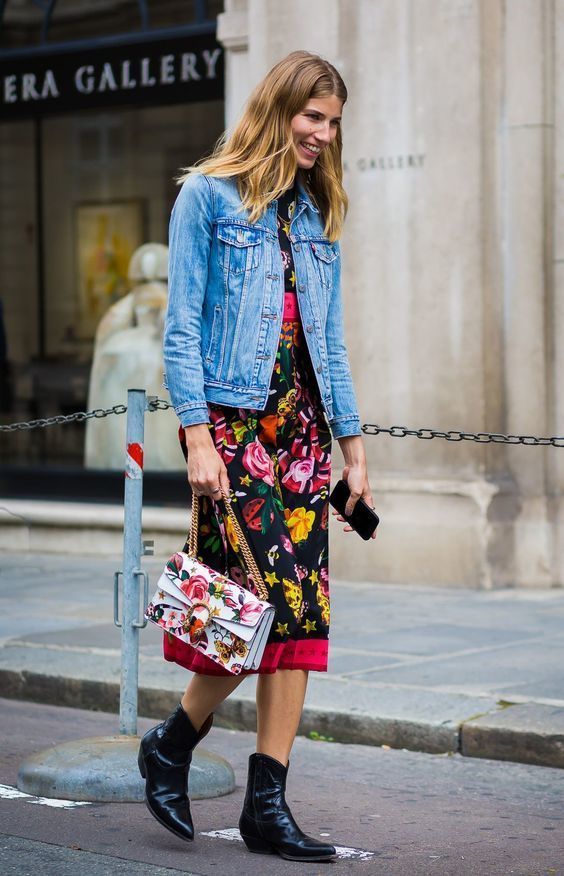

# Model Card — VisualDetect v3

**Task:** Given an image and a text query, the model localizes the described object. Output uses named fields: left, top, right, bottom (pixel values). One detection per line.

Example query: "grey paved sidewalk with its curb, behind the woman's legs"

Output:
left=0, top=553, right=564, bottom=767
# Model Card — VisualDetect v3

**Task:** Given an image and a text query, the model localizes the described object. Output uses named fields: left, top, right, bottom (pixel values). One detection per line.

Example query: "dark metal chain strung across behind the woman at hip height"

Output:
left=0, top=395, right=564, bottom=447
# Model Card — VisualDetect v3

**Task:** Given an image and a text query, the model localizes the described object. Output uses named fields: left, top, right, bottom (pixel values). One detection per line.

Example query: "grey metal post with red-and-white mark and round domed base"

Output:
left=17, top=389, right=235, bottom=802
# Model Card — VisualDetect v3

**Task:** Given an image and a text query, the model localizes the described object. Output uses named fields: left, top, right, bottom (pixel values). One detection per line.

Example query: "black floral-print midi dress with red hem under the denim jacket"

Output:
left=164, top=183, right=331, bottom=675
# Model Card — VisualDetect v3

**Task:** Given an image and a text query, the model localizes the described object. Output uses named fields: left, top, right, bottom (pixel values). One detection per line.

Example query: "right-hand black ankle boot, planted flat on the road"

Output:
left=239, top=754, right=336, bottom=861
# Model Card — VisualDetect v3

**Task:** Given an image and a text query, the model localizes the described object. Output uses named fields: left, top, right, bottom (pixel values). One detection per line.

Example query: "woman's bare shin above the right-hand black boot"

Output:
left=257, top=669, right=308, bottom=766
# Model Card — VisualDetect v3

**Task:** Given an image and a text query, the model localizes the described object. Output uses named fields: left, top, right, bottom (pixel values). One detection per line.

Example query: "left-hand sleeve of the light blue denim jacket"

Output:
left=163, top=174, right=213, bottom=426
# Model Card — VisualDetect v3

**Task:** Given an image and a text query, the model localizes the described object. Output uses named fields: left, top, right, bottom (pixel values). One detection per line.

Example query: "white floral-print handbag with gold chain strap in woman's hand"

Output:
left=145, top=482, right=275, bottom=674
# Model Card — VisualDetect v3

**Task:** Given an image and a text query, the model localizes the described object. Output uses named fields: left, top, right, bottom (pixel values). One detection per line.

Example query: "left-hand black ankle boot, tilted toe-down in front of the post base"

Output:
left=137, top=704, right=213, bottom=840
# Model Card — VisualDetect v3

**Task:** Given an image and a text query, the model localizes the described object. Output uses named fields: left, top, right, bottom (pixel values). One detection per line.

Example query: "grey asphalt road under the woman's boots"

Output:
left=0, top=700, right=564, bottom=876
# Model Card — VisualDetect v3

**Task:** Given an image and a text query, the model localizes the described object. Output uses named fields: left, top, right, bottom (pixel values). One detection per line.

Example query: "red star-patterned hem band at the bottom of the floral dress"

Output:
left=163, top=633, right=329, bottom=676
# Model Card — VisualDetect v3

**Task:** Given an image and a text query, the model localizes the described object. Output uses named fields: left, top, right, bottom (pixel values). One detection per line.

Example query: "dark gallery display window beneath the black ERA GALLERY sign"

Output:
left=0, top=101, right=223, bottom=476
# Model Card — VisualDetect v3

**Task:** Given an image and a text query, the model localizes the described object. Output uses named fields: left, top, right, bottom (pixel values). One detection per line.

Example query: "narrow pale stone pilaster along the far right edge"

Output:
left=491, top=0, right=557, bottom=585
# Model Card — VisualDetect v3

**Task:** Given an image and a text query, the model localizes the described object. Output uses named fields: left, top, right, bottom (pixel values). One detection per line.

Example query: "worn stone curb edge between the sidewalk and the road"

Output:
left=0, top=669, right=564, bottom=769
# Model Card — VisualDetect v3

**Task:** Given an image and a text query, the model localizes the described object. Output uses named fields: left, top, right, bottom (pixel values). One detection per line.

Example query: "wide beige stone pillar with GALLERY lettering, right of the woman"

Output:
left=333, top=0, right=497, bottom=586
